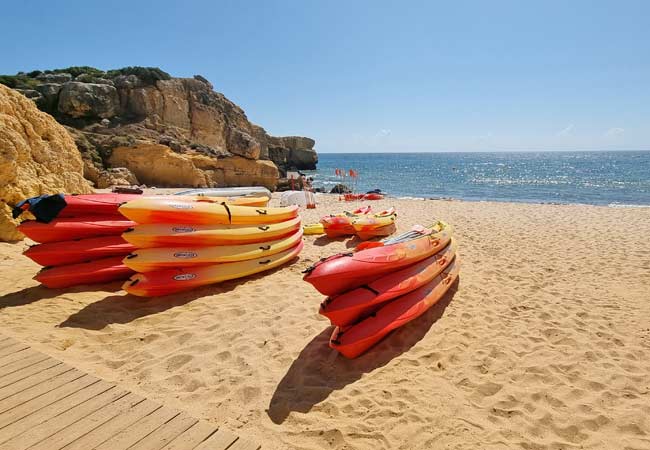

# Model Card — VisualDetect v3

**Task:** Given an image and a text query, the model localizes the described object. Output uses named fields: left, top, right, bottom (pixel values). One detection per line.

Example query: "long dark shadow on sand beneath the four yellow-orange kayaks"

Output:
left=59, top=259, right=292, bottom=330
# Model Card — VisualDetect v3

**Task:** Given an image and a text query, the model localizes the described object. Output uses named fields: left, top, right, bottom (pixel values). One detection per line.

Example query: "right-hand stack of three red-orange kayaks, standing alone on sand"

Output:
left=304, top=221, right=460, bottom=358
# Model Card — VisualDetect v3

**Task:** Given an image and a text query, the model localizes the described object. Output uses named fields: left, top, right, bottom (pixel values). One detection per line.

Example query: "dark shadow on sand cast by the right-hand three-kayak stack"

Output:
left=266, top=279, right=460, bottom=424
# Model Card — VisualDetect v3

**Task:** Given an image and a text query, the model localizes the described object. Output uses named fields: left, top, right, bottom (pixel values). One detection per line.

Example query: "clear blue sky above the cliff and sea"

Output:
left=0, top=0, right=650, bottom=152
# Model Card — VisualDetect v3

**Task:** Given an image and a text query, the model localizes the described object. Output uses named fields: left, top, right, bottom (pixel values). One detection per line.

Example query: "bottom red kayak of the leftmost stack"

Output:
left=34, top=256, right=135, bottom=288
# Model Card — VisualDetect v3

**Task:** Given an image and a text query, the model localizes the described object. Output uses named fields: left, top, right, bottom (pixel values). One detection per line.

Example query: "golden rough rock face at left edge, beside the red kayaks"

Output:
left=0, top=85, right=91, bottom=241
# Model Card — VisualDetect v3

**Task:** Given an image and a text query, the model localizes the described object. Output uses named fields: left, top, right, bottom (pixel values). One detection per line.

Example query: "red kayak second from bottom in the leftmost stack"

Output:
left=23, top=236, right=136, bottom=266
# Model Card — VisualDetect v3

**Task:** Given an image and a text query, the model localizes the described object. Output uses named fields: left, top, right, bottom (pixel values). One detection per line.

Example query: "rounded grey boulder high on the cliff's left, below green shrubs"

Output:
left=58, top=81, right=120, bottom=119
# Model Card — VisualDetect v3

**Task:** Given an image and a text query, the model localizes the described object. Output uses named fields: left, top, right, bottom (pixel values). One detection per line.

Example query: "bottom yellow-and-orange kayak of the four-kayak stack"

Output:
left=122, top=241, right=303, bottom=297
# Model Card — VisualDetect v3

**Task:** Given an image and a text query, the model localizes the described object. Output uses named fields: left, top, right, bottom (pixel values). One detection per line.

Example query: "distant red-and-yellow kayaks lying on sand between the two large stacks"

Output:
left=320, top=206, right=397, bottom=241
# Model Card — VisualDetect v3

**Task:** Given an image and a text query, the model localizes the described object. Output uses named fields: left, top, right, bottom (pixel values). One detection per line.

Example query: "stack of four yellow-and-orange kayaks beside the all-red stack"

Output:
left=120, top=198, right=303, bottom=297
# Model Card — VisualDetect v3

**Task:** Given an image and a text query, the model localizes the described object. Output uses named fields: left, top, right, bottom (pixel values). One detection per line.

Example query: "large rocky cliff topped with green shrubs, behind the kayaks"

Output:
left=0, top=67, right=318, bottom=189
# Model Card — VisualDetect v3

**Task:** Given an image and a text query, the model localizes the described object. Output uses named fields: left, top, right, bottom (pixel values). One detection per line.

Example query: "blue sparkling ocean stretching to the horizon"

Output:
left=307, top=151, right=650, bottom=206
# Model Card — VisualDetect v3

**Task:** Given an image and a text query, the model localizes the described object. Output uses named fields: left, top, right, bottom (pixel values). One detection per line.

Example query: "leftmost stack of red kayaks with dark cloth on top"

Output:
left=18, top=194, right=140, bottom=288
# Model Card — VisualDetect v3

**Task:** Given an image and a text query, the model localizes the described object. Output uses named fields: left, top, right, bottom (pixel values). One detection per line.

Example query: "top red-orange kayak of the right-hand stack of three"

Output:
left=303, top=222, right=452, bottom=296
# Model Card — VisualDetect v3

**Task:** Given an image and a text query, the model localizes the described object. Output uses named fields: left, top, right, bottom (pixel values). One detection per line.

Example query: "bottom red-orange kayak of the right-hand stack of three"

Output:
left=330, top=258, right=460, bottom=358
